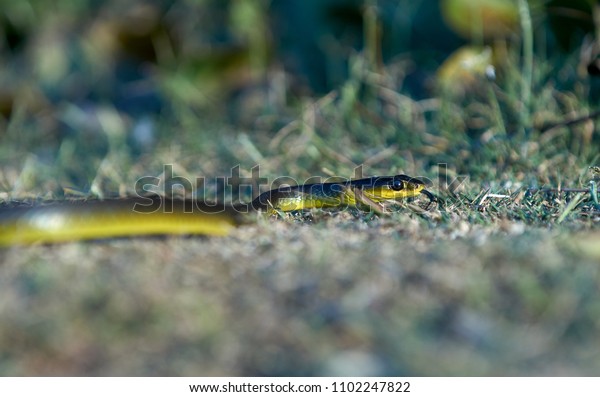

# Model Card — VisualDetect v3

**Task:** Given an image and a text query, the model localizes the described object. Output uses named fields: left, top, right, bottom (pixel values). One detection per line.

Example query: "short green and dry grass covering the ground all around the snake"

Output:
left=0, top=1, right=600, bottom=375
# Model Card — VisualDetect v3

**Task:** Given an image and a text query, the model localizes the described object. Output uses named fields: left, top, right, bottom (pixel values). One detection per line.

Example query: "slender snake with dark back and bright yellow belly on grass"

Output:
left=0, top=175, right=436, bottom=246
